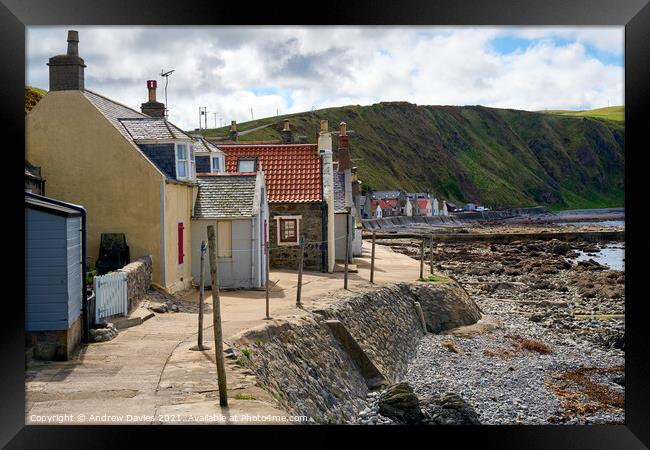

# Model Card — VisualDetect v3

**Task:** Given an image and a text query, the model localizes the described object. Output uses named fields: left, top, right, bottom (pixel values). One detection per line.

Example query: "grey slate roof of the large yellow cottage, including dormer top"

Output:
left=83, top=90, right=190, bottom=141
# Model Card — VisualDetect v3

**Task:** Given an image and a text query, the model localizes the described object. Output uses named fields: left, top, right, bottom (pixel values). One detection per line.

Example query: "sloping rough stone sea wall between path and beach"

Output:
left=234, top=281, right=481, bottom=424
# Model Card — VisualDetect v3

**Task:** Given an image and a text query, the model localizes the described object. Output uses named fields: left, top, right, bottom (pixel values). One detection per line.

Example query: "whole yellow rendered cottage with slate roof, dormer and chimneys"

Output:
left=26, top=31, right=202, bottom=292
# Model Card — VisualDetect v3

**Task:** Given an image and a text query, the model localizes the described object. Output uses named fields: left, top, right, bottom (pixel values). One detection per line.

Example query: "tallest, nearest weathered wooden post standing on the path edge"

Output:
left=208, top=225, right=228, bottom=406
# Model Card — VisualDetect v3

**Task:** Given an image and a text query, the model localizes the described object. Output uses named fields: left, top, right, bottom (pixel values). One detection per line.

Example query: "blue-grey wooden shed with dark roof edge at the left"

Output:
left=25, top=193, right=85, bottom=359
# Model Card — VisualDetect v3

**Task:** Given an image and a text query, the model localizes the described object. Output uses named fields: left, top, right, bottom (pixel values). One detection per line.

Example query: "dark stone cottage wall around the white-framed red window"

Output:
left=269, top=203, right=325, bottom=271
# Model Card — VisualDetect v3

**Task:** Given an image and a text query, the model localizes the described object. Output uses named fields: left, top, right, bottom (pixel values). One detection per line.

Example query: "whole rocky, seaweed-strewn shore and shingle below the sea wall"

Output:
left=355, top=236, right=625, bottom=424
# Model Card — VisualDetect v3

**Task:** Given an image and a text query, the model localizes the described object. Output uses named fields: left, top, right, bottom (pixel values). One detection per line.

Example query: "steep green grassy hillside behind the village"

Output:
left=194, top=102, right=625, bottom=209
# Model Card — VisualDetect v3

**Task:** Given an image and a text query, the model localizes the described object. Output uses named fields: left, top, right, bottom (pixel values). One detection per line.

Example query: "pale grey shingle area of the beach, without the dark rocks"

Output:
left=406, top=312, right=624, bottom=424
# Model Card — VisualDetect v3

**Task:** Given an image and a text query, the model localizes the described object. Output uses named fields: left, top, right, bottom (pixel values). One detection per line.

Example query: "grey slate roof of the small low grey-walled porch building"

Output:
left=194, top=174, right=257, bottom=219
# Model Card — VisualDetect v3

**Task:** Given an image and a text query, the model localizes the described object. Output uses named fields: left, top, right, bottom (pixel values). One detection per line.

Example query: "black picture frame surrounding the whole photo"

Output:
left=0, top=0, right=650, bottom=449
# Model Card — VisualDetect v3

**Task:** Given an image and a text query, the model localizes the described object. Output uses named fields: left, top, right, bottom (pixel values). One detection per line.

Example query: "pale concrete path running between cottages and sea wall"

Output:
left=25, top=242, right=419, bottom=424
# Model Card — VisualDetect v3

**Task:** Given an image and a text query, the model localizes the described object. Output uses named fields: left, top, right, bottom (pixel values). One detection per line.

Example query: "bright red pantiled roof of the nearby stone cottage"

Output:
left=217, top=144, right=323, bottom=203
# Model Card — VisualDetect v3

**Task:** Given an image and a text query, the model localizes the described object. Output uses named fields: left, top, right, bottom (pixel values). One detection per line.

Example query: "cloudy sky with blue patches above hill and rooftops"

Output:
left=25, top=26, right=624, bottom=129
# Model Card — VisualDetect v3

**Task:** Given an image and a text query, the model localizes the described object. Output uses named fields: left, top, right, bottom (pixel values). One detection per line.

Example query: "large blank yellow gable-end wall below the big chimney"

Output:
left=25, top=91, right=165, bottom=284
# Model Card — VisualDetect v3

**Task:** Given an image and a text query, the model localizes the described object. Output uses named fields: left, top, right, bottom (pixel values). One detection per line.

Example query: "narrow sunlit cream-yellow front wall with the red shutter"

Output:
left=165, top=183, right=193, bottom=292
